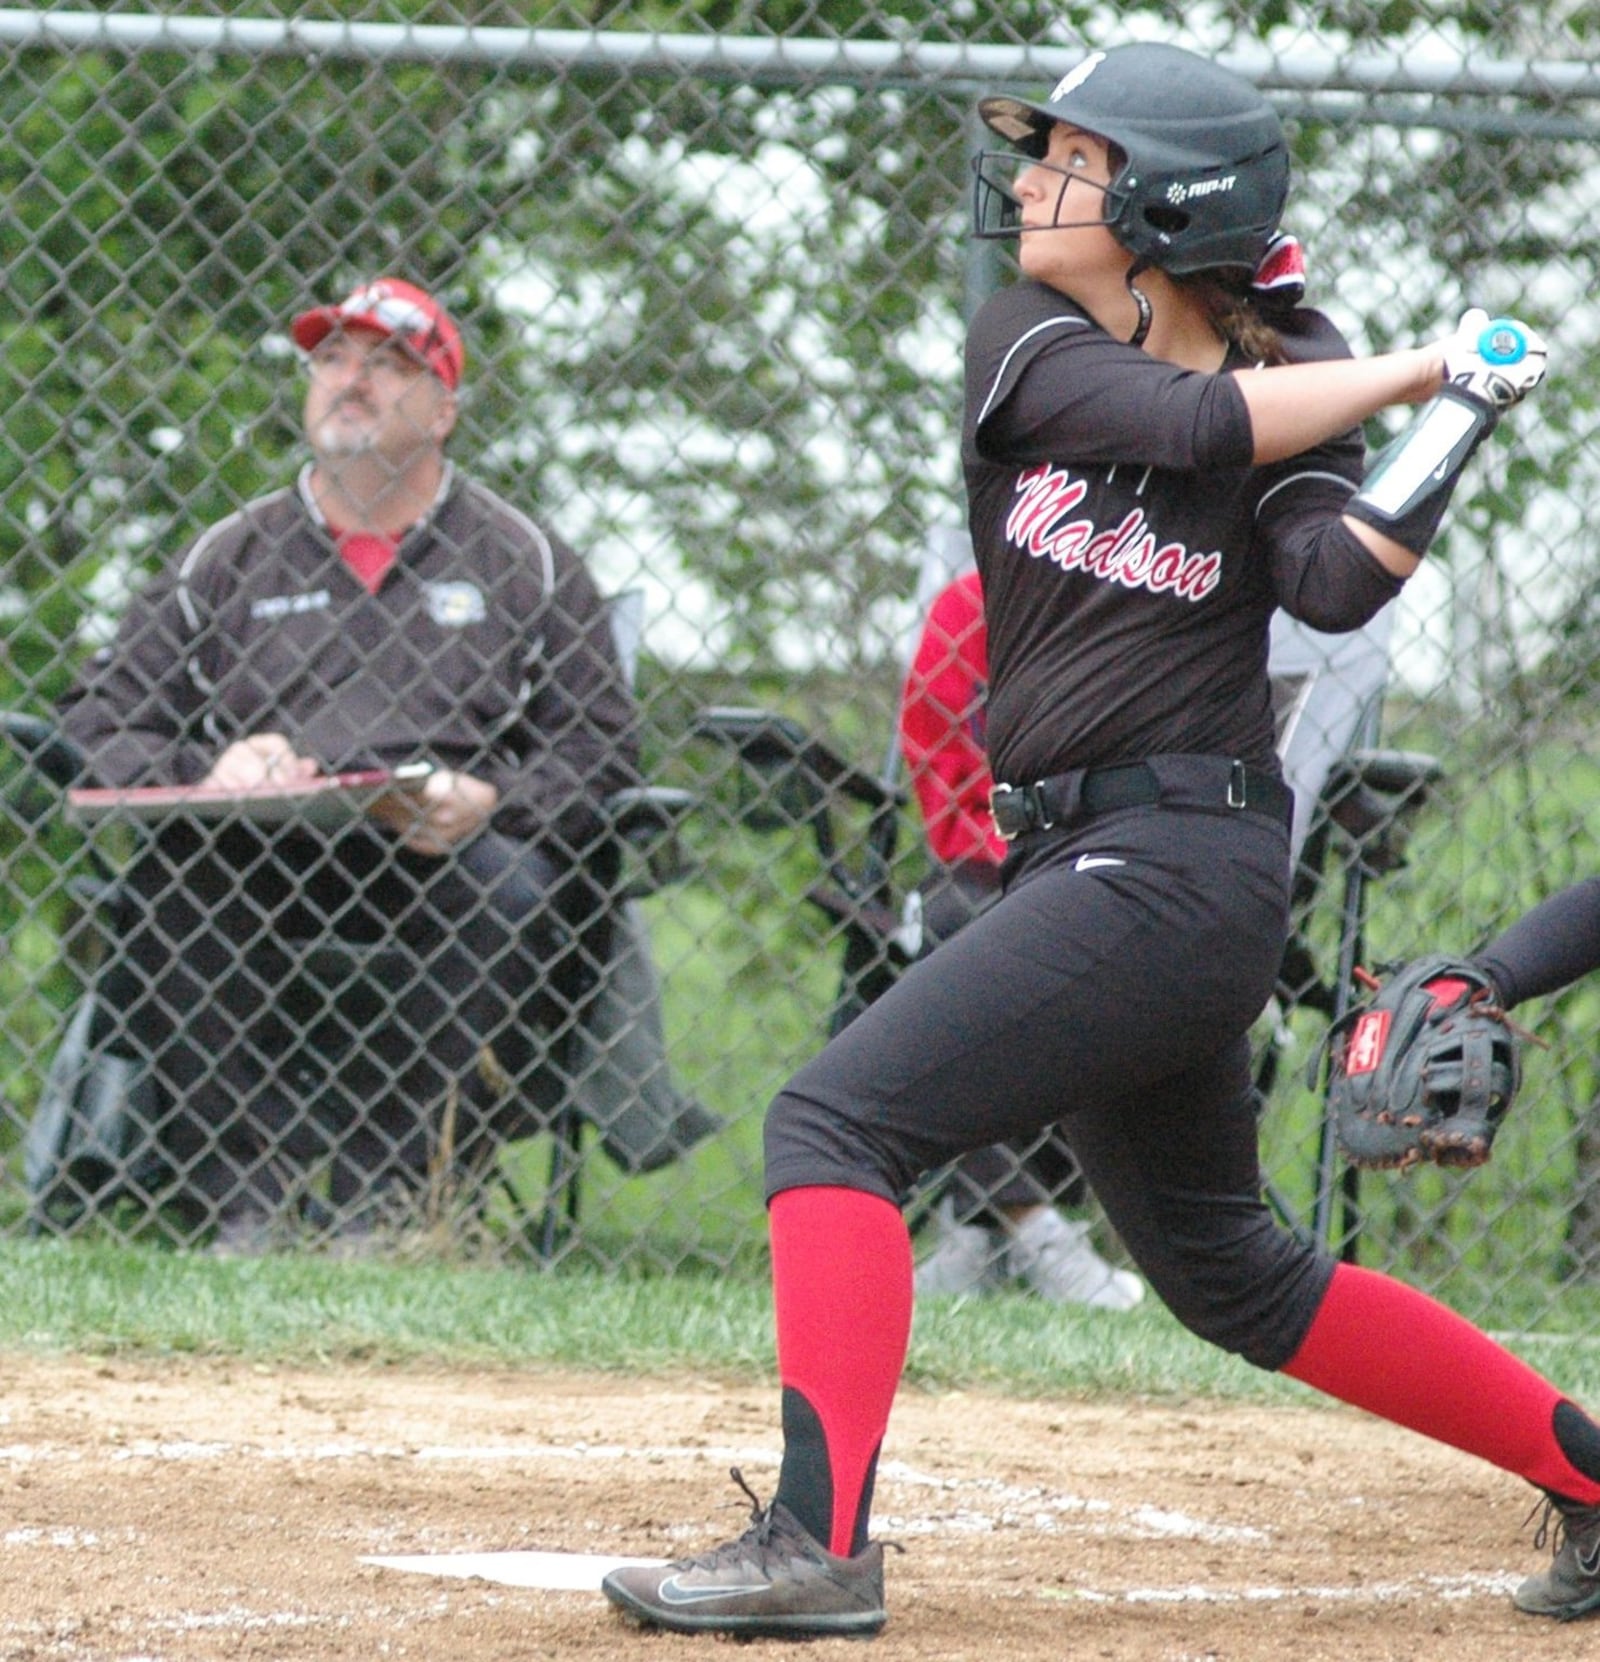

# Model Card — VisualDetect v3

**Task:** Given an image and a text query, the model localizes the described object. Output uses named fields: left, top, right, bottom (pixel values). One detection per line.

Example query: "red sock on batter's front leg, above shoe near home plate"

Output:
left=769, top=1188, right=910, bottom=1554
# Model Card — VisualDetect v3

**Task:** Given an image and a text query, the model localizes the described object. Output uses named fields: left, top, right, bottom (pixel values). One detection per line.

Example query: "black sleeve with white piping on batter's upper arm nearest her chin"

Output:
left=967, top=283, right=1254, bottom=470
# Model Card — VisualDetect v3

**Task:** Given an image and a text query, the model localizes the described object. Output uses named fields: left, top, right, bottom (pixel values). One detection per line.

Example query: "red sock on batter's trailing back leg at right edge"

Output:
left=1283, top=1263, right=1600, bottom=1506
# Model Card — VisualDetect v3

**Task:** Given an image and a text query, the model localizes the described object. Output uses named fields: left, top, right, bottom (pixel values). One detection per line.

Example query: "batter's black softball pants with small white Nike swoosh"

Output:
left=766, top=806, right=1333, bottom=1368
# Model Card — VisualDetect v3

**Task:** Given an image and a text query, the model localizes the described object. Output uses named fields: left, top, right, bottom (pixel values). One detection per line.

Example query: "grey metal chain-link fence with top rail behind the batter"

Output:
left=0, top=0, right=1600, bottom=1325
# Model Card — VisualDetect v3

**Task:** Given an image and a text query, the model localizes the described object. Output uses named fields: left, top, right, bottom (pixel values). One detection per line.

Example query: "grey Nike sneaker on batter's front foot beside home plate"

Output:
left=600, top=1469, right=889, bottom=1639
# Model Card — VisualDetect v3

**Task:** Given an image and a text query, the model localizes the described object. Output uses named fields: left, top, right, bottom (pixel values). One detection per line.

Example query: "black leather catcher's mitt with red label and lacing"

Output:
left=1328, top=956, right=1522, bottom=1167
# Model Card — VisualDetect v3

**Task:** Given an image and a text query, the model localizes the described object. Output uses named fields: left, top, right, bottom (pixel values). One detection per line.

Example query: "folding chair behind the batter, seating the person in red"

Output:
left=698, top=529, right=1442, bottom=1256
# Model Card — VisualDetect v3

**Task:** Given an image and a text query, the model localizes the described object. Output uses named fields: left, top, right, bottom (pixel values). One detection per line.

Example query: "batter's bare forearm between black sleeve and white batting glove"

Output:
left=1234, top=344, right=1444, bottom=468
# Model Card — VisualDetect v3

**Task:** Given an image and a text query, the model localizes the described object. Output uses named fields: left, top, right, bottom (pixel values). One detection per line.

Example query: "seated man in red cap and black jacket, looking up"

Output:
left=65, top=278, right=635, bottom=1250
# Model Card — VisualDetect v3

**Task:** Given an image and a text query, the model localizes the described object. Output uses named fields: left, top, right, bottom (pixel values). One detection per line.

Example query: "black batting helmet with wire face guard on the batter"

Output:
left=974, top=43, right=1289, bottom=276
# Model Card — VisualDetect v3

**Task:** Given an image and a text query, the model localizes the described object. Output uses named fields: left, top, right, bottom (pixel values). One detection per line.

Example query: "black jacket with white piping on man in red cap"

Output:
left=63, top=469, right=636, bottom=851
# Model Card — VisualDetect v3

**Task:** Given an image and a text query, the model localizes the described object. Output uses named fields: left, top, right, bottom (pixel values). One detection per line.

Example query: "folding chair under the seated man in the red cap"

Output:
left=0, top=592, right=694, bottom=1255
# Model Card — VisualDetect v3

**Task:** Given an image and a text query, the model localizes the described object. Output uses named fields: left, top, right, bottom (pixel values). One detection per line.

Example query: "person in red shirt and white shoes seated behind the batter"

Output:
left=901, top=570, right=1145, bottom=1310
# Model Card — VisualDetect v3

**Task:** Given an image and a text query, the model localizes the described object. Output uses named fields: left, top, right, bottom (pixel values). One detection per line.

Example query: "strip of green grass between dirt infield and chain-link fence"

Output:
left=9, top=1242, right=1600, bottom=1403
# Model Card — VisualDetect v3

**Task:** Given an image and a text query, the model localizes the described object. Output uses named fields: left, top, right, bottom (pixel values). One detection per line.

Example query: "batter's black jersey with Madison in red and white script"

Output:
left=962, top=281, right=1401, bottom=783
